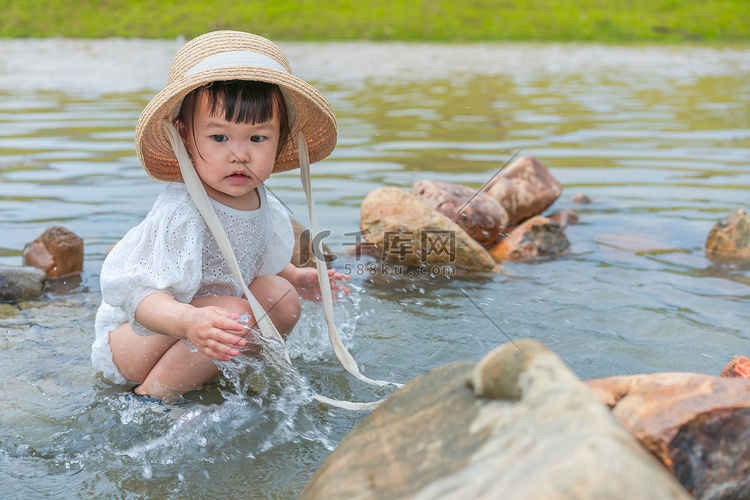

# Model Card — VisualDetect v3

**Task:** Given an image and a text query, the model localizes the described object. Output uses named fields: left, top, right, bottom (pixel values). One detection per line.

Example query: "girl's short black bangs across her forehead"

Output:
left=201, top=80, right=286, bottom=124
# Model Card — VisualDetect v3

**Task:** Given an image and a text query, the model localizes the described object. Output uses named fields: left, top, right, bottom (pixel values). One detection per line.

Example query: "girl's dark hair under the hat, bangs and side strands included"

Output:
left=177, top=80, right=291, bottom=155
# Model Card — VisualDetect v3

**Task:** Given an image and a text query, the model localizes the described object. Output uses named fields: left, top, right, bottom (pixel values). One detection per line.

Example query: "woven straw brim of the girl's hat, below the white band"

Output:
left=135, top=66, right=336, bottom=182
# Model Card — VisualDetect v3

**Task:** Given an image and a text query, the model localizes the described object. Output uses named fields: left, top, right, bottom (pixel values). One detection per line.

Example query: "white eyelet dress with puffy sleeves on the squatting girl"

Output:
left=91, top=182, right=294, bottom=383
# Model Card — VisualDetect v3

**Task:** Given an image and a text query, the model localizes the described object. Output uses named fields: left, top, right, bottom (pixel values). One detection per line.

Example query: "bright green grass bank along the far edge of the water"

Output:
left=0, top=0, right=750, bottom=42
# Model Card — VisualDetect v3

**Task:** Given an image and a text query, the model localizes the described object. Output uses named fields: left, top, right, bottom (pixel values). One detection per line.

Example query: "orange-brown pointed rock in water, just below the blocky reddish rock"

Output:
left=490, top=215, right=570, bottom=262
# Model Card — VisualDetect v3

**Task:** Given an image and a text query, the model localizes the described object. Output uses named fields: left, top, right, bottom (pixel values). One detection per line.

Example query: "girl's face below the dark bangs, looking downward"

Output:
left=183, top=95, right=279, bottom=210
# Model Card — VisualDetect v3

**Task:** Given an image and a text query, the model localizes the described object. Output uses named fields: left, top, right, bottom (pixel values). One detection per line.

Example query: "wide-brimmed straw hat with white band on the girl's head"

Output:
left=135, top=31, right=336, bottom=182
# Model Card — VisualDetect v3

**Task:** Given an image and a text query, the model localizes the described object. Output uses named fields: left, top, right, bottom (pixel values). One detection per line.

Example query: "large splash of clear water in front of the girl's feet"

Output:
left=121, top=330, right=335, bottom=464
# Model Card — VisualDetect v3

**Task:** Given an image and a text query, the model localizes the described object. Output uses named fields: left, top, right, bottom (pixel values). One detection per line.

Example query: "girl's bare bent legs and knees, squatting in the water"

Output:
left=109, top=276, right=300, bottom=401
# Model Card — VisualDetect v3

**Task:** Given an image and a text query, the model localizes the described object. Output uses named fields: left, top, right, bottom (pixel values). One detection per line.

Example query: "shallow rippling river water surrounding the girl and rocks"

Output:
left=0, top=40, right=750, bottom=498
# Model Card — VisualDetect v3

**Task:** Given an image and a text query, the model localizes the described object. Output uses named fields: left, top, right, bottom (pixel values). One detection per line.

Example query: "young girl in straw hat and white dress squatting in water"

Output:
left=91, top=31, right=349, bottom=401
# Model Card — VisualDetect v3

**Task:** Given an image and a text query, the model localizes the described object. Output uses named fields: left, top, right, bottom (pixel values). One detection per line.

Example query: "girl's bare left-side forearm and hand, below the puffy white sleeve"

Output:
left=135, top=292, right=245, bottom=361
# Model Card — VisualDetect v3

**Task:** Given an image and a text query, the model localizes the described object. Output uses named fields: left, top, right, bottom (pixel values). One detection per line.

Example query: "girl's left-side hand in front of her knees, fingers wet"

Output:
left=185, top=306, right=246, bottom=361
